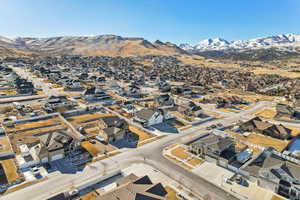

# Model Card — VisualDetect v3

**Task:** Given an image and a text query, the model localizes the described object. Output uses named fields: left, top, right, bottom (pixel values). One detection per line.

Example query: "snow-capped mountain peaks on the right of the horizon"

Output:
left=180, top=34, right=300, bottom=53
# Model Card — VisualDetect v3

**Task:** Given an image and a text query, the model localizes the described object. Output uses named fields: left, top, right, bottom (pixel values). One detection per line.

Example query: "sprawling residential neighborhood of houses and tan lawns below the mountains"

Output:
left=0, top=56, right=300, bottom=200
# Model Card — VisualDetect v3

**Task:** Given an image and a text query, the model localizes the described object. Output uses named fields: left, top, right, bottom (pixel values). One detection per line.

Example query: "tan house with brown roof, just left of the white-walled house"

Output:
left=98, top=116, right=129, bottom=143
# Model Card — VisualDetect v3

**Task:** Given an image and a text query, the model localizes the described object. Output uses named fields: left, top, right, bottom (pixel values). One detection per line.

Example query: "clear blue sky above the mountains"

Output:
left=0, top=0, right=300, bottom=44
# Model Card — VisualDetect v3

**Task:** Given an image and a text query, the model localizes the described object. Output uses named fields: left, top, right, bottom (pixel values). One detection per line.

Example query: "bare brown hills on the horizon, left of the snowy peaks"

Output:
left=0, top=35, right=187, bottom=57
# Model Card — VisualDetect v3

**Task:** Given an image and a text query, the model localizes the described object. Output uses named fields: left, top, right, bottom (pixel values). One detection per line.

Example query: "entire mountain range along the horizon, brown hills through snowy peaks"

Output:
left=0, top=34, right=300, bottom=59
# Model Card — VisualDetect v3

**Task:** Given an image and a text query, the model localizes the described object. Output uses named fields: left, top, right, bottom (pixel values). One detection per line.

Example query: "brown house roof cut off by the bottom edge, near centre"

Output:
left=94, top=174, right=167, bottom=200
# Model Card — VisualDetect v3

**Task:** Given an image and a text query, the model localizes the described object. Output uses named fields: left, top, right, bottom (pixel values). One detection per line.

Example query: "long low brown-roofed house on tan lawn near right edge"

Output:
left=240, top=117, right=292, bottom=140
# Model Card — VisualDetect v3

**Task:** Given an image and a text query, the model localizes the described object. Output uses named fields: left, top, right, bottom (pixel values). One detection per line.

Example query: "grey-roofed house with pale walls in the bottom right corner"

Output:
left=242, top=148, right=300, bottom=200
